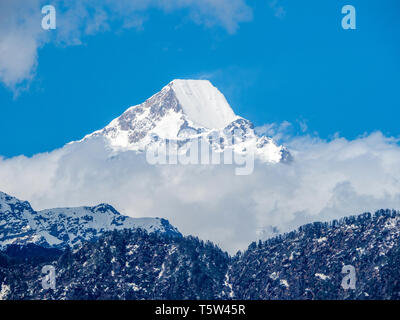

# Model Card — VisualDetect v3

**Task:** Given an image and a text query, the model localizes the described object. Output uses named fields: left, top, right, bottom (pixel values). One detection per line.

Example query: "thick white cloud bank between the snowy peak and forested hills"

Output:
left=0, top=129, right=400, bottom=252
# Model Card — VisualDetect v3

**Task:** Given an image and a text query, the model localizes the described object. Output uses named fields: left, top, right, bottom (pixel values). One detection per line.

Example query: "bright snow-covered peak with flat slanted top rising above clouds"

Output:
left=81, top=79, right=290, bottom=163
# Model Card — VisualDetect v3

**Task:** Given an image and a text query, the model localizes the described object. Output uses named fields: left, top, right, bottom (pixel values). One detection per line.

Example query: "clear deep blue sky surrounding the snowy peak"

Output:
left=0, top=0, right=400, bottom=157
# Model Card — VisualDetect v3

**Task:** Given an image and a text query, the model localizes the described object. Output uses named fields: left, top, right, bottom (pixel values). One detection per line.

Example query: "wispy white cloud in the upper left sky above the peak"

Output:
left=0, top=0, right=252, bottom=91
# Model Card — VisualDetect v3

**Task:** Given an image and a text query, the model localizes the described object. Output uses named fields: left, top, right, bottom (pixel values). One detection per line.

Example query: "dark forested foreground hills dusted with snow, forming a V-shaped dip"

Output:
left=0, top=205, right=400, bottom=300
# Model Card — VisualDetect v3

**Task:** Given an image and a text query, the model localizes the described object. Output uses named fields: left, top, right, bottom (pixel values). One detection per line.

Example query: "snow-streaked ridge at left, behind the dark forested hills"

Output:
left=0, top=192, right=180, bottom=248
